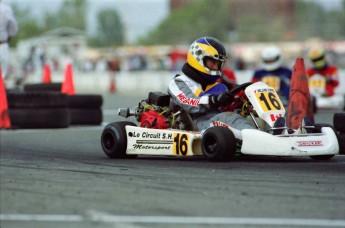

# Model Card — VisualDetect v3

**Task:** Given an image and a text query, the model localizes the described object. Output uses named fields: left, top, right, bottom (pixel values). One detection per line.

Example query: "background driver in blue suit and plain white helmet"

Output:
left=252, top=46, right=292, bottom=101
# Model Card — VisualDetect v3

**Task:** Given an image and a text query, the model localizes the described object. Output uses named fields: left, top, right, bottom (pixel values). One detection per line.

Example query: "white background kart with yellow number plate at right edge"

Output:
left=308, top=74, right=345, bottom=111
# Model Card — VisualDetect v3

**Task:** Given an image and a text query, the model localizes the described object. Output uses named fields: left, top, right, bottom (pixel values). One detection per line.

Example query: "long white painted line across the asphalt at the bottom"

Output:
left=0, top=213, right=345, bottom=227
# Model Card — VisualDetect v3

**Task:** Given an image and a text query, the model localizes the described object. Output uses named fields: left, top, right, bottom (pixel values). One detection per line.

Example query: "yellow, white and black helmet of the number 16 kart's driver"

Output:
left=187, top=37, right=227, bottom=81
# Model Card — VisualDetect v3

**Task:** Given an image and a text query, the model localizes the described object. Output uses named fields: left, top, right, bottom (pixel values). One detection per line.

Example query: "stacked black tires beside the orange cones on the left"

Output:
left=7, top=83, right=103, bottom=128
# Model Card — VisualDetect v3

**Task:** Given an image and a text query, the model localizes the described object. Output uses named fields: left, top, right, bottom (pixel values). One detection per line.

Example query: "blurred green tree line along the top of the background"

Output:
left=11, top=0, right=345, bottom=47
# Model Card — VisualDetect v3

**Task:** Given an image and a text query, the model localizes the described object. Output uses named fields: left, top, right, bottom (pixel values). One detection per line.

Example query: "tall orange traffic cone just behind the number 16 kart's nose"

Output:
left=287, top=58, right=315, bottom=129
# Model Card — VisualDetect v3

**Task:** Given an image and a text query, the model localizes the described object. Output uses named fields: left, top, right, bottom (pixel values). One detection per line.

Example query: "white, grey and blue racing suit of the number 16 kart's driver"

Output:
left=168, top=63, right=255, bottom=139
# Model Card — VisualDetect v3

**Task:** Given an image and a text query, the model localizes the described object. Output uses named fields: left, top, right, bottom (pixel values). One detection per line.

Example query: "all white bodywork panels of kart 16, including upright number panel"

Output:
left=119, top=82, right=339, bottom=159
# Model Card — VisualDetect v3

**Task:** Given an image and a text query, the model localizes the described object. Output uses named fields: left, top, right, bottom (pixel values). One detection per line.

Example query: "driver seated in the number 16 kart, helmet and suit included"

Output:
left=168, top=37, right=255, bottom=140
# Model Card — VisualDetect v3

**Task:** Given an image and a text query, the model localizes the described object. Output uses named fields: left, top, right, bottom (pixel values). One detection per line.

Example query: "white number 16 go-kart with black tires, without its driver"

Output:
left=101, top=82, right=342, bottom=161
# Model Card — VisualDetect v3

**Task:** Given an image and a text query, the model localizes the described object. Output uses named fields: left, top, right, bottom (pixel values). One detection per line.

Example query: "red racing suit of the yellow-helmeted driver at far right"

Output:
left=307, top=65, right=339, bottom=96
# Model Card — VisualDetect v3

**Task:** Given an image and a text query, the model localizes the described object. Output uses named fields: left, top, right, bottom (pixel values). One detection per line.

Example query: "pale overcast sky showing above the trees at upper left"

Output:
left=2, top=0, right=169, bottom=42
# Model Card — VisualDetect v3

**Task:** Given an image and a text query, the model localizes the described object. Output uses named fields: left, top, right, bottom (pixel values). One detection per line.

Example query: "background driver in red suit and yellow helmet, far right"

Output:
left=307, top=48, right=339, bottom=96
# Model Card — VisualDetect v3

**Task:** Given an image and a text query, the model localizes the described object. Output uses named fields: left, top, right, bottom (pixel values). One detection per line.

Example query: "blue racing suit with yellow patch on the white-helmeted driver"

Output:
left=252, top=67, right=292, bottom=100
